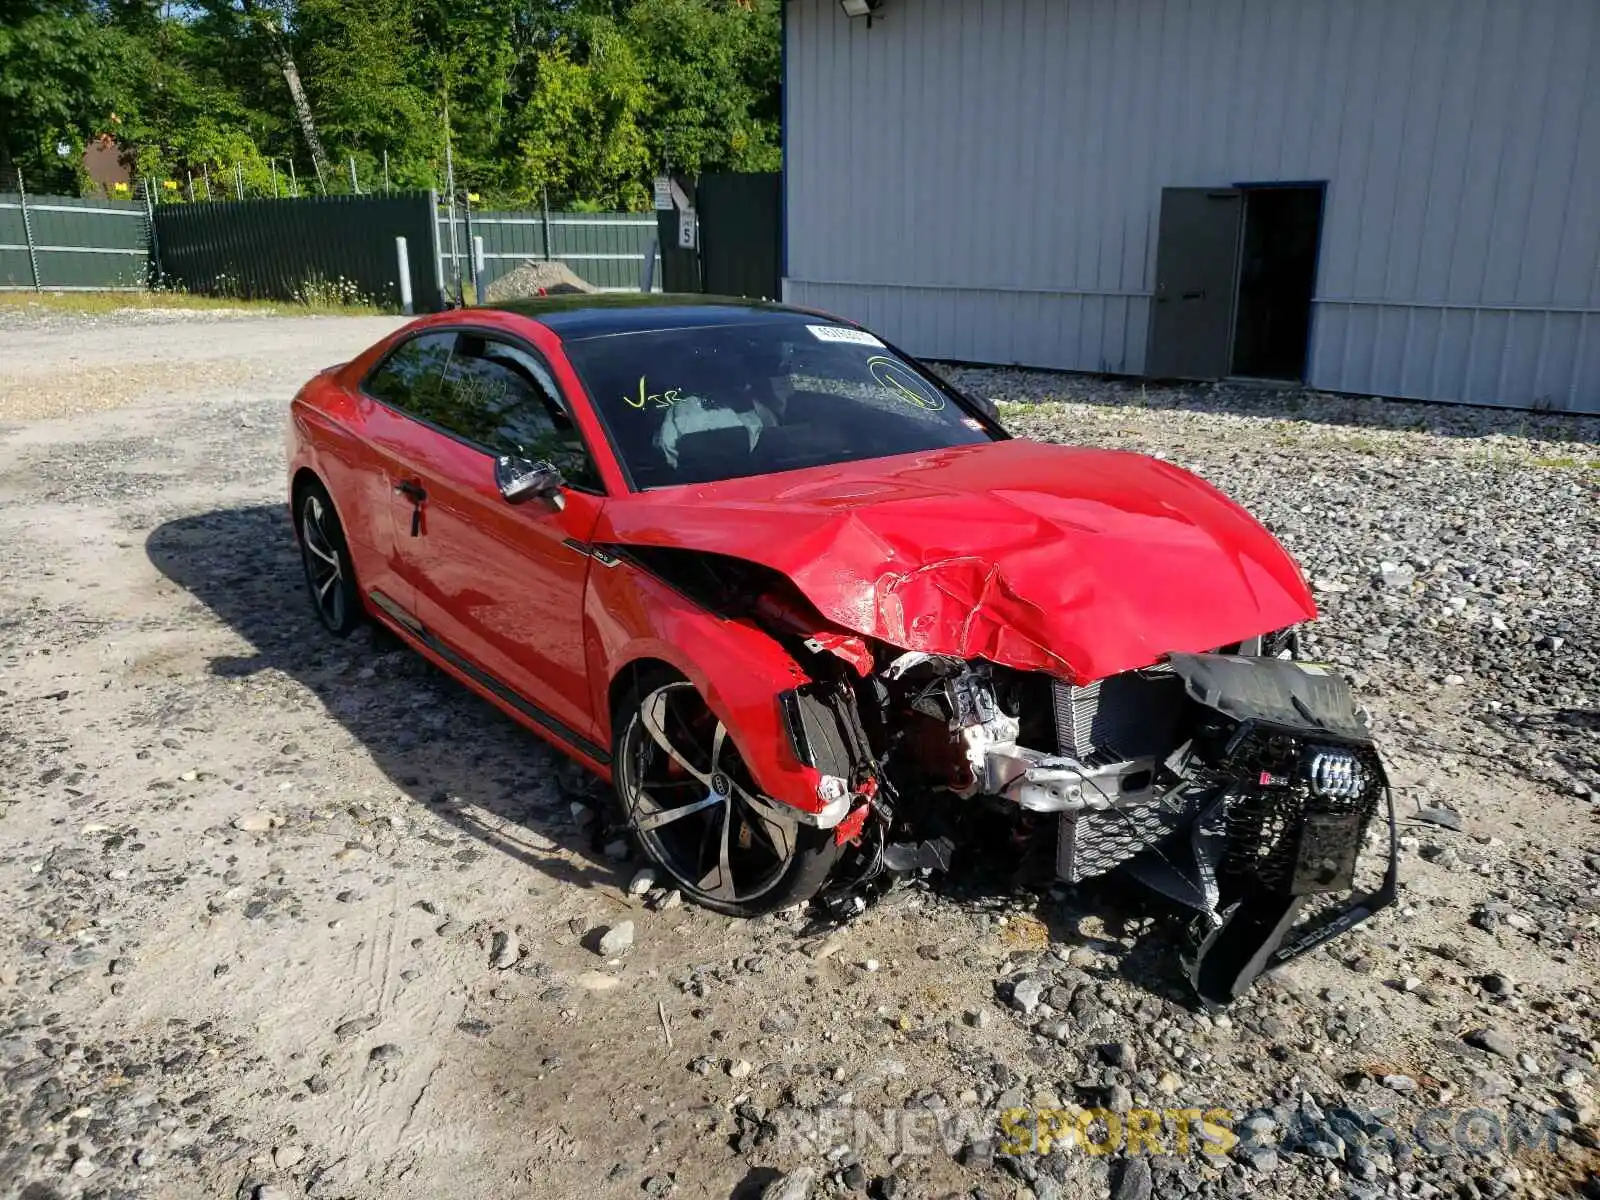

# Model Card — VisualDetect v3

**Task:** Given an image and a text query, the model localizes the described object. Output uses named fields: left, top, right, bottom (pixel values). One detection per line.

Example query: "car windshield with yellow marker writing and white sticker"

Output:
left=566, top=317, right=995, bottom=490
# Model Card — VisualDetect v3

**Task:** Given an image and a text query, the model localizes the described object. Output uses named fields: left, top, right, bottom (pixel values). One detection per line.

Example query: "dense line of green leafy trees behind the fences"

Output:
left=9, top=0, right=781, bottom=208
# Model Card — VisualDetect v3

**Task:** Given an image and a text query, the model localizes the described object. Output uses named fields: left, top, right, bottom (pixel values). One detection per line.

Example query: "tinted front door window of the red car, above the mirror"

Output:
left=437, top=333, right=603, bottom=491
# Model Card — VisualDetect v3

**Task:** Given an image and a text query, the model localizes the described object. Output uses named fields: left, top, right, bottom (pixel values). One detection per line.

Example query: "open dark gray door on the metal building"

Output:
left=1144, top=187, right=1245, bottom=379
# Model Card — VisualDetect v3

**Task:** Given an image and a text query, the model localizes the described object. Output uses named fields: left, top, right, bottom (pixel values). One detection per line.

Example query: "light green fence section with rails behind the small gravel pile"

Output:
left=438, top=208, right=661, bottom=293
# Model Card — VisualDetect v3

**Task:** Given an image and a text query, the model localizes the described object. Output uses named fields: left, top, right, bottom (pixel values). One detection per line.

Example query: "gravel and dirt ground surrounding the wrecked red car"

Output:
left=0, top=314, right=1600, bottom=1200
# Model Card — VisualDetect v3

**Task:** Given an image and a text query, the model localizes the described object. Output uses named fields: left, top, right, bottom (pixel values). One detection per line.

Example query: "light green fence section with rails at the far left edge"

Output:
left=0, top=192, right=150, bottom=291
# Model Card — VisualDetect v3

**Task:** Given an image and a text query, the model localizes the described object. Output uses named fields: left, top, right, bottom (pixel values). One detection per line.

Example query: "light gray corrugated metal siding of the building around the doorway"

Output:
left=786, top=0, right=1600, bottom=411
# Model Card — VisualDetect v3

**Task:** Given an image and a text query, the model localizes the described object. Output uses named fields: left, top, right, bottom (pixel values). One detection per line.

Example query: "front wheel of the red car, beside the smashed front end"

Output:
left=611, top=675, right=838, bottom=917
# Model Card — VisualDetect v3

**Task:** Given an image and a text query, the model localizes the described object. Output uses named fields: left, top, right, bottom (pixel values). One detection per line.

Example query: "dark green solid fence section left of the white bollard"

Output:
left=155, top=192, right=443, bottom=312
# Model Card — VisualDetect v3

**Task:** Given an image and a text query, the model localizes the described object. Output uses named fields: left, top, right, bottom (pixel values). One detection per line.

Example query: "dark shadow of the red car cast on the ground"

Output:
left=146, top=504, right=630, bottom=888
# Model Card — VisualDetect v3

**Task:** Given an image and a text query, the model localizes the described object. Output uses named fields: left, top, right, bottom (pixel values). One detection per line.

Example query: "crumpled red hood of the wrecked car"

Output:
left=594, top=440, right=1317, bottom=682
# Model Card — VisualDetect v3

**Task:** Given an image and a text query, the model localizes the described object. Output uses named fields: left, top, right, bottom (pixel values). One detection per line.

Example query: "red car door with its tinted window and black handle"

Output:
left=368, top=330, right=605, bottom=761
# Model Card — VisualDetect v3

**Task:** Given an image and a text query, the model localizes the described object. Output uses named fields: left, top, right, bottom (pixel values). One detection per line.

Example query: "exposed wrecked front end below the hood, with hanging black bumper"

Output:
left=779, top=630, right=1397, bottom=1005
